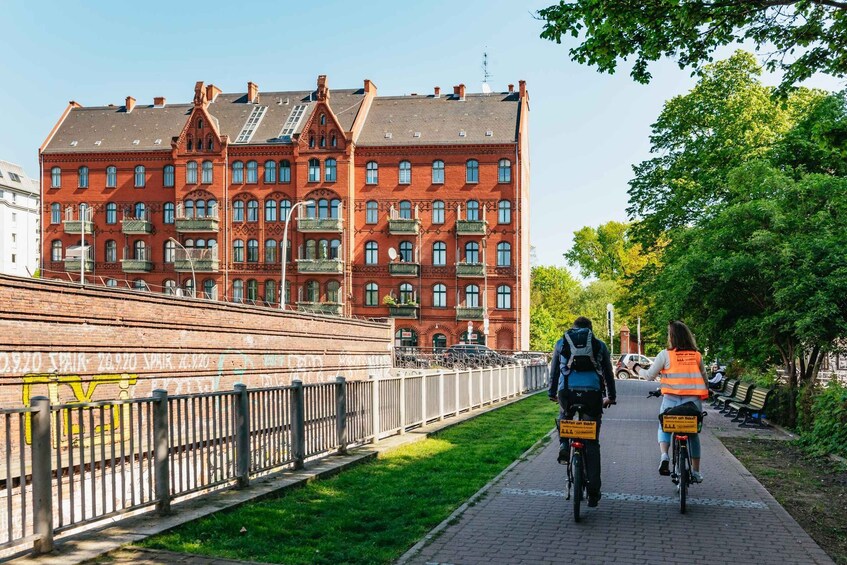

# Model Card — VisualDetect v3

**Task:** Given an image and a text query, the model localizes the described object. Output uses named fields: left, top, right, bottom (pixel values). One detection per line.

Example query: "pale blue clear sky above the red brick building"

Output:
left=0, top=0, right=842, bottom=265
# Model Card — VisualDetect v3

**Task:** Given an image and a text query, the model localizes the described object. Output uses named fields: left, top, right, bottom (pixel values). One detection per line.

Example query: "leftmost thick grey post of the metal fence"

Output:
left=30, top=396, right=53, bottom=554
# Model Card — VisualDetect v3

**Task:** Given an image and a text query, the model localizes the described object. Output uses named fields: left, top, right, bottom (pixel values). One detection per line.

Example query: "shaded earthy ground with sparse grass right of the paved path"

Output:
left=720, top=437, right=847, bottom=565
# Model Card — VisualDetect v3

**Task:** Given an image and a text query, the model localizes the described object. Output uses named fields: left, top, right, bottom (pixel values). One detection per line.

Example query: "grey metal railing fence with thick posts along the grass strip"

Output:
left=0, top=364, right=547, bottom=553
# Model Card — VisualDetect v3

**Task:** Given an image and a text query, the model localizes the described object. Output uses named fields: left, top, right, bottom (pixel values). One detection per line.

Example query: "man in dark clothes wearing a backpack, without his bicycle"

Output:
left=547, top=316, right=616, bottom=507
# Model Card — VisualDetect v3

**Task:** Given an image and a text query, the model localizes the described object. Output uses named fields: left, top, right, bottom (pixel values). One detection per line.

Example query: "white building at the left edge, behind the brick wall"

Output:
left=0, top=161, right=41, bottom=277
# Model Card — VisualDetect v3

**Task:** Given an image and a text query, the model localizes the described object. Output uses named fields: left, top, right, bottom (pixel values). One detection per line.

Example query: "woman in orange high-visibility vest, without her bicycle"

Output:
left=639, top=321, right=709, bottom=483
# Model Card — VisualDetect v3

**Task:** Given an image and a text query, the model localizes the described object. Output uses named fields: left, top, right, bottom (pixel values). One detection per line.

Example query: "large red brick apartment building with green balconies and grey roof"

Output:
left=40, top=76, right=529, bottom=349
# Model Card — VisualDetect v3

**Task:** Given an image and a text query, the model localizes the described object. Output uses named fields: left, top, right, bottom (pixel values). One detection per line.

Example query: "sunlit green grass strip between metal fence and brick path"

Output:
left=138, top=394, right=556, bottom=564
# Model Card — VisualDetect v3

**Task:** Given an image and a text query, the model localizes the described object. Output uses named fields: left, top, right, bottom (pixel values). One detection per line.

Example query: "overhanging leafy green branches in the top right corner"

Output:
left=538, top=0, right=847, bottom=90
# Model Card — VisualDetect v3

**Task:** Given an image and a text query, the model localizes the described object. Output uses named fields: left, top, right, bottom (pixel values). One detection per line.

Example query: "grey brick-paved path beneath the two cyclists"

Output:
left=407, top=381, right=833, bottom=565
